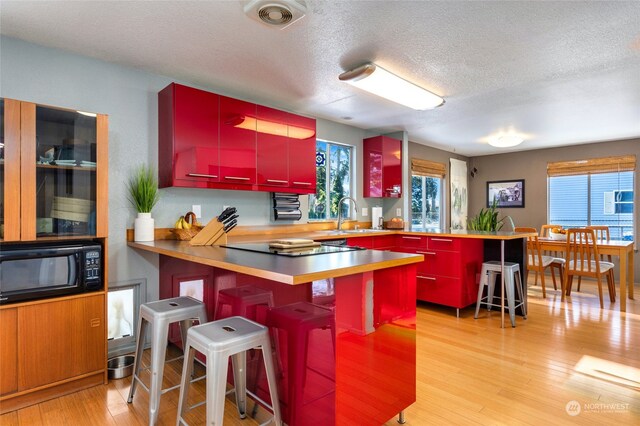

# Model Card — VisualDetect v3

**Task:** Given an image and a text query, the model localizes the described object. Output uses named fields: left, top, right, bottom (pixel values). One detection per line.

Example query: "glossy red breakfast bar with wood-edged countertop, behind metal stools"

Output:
left=128, top=240, right=423, bottom=426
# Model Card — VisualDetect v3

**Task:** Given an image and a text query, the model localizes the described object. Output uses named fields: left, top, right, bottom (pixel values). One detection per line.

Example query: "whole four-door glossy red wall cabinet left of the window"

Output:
left=158, top=83, right=316, bottom=194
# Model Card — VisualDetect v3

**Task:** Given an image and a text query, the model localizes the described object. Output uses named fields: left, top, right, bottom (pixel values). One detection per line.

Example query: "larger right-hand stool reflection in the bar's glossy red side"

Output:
left=267, top=302, right=336, bottom=426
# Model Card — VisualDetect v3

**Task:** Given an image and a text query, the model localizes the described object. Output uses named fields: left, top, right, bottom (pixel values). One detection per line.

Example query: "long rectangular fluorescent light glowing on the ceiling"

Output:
left=339, top=63, right=444, bottom=110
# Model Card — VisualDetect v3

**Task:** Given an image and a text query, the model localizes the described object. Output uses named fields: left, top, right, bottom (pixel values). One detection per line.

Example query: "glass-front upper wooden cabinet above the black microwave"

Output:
left=0, top=99, right=108, bottom=241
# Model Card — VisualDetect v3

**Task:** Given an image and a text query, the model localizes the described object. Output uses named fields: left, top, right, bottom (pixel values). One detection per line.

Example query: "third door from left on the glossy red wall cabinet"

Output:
left=256, top=105, right=291, bottom=186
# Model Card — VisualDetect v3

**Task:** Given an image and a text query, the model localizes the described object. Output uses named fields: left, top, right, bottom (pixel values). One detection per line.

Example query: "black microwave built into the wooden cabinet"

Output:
left=0, top=241, right=103, bottom=304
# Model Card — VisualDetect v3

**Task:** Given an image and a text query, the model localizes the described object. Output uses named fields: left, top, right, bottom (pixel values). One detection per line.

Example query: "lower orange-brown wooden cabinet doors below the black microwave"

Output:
left=0, top=292, right=107, bottom=413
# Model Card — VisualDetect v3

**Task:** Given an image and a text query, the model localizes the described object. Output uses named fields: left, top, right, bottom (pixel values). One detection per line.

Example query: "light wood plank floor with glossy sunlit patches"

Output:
left=0, top=279, right=640, bottom=426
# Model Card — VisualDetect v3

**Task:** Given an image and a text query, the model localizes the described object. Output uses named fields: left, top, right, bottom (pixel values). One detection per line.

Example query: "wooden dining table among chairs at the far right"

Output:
left=538, top=238, right=634, bottom=312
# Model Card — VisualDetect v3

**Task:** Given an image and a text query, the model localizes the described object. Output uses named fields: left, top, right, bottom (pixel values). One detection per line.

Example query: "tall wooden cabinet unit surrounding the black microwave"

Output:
left=0, top=99, right=109, bottom=413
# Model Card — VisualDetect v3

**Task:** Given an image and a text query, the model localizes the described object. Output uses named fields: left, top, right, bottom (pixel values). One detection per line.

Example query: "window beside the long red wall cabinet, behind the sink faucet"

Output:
left=309, top=140, right=353, bottom=220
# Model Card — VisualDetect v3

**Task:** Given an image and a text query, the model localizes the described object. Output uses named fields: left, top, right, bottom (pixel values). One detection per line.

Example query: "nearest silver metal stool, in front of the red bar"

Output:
left=177, top=317, right=282, bottom=426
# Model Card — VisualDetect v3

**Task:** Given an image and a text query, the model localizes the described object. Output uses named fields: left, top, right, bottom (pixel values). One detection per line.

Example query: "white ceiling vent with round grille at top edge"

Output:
left=244, top=0, right=307, bottom=30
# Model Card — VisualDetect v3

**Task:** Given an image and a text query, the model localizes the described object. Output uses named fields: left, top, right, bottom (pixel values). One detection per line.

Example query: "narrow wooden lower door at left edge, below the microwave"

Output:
left=0, top=309, right=18, bottom=396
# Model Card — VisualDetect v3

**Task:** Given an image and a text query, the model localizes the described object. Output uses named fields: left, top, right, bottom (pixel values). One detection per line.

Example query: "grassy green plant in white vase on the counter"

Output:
left=128, top=165, right=160, bottom=241
